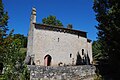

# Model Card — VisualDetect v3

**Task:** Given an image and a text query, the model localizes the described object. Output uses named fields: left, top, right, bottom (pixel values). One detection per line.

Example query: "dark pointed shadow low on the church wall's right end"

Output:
left=76, top=52, right=90, bottom=65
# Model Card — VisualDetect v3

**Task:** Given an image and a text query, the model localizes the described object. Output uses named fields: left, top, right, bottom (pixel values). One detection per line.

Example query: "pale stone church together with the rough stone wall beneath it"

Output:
left=25, top=8, right=95, bottom=80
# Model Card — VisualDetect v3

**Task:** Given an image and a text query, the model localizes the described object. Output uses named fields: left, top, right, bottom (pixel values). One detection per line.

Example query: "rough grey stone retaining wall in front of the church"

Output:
left=28, top=65, right=95, bottom=80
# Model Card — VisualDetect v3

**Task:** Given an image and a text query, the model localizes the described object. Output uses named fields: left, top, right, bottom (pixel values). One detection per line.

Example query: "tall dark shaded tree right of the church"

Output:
left=93, top=0, right=120, bottom=77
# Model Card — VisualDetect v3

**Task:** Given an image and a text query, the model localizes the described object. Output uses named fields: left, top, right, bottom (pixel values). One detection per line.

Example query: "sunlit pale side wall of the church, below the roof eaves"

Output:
left=33, top=29, right=91, bottom=66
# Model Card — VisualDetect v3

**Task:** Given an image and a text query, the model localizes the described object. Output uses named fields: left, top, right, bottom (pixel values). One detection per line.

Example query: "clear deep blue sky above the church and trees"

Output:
left=3, top=0, right=97, bottom=41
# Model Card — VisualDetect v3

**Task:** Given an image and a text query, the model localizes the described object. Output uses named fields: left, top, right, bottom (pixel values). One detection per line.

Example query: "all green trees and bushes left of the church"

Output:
left=0, top=0, right=29, bottom=80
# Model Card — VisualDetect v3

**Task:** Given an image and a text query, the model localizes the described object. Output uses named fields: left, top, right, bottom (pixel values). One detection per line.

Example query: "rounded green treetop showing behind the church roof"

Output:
left=42, top=15, right=63, bottom=27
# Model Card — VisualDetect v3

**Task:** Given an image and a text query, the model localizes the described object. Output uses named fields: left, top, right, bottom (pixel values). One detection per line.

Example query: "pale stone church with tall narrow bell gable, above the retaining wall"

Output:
left=25, top=8, right=93, bottom=66
